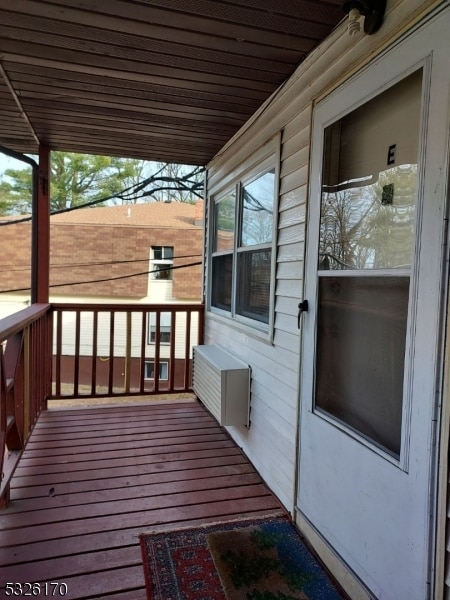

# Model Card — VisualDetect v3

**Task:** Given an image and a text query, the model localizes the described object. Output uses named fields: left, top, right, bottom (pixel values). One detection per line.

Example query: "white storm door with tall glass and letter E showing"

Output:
left=297, top=11, right=450, bottom=600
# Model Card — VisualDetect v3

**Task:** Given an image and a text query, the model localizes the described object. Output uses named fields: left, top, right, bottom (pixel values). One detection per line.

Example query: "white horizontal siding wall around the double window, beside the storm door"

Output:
left=205, top=0, right=442, bottom=511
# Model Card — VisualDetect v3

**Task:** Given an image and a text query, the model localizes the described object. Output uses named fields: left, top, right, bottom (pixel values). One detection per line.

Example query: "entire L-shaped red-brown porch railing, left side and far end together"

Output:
left=0, top=304, right=204, bottom=508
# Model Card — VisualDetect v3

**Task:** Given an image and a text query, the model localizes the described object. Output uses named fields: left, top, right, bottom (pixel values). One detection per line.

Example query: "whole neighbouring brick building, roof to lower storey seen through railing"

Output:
left=0, top=202, right=203, bottom=389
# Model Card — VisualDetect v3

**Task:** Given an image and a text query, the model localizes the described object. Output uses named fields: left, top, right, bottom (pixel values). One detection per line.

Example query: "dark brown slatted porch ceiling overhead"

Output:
left=0, top=0, right=344, bottom=164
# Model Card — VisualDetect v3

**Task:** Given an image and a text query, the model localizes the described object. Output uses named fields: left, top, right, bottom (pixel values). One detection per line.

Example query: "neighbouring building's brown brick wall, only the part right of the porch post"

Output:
left=50, top=223, right=202, bottom=300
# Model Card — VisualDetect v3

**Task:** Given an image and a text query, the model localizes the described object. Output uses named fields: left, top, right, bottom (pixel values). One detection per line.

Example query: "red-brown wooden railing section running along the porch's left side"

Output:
left=0, top=304, right=52, bottom=507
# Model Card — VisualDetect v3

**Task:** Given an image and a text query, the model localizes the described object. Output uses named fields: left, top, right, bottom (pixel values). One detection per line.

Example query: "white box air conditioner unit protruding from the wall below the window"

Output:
left=192, top=346, right=250, bottom=427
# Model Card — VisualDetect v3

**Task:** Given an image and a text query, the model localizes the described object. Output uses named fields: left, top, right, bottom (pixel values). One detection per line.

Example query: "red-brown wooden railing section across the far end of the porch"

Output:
left=52, top=303, right=204, bottom=398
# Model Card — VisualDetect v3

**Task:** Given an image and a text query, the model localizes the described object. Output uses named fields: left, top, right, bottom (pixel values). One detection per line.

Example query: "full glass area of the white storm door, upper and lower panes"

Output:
left=315, top=71, right=422, bottom=456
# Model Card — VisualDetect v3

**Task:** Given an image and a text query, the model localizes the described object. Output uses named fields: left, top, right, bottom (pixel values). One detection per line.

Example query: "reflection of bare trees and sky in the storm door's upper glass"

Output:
left=319, top=164, right=417, bottom=270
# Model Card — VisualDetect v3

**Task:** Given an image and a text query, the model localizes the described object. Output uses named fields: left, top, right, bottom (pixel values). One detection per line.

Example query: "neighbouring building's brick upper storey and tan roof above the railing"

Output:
left=0, top=202, right=203, bottom=304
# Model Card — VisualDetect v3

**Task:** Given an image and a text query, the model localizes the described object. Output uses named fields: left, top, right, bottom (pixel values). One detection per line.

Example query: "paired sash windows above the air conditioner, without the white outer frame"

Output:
left=211, top=159, right=276, bottom=326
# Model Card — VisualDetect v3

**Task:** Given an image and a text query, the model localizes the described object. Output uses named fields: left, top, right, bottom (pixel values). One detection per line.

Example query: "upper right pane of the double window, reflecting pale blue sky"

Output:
left=241, top=170, right=275, bottom=246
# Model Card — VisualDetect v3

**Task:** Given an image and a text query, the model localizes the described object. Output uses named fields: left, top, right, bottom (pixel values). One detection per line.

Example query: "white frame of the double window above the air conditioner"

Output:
left=207, top=135, right=280, bottom=342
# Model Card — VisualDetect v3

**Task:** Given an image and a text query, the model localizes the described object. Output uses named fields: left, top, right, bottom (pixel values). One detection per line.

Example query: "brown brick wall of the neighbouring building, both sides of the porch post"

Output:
left=0, top=220, right=203, bottom=301
